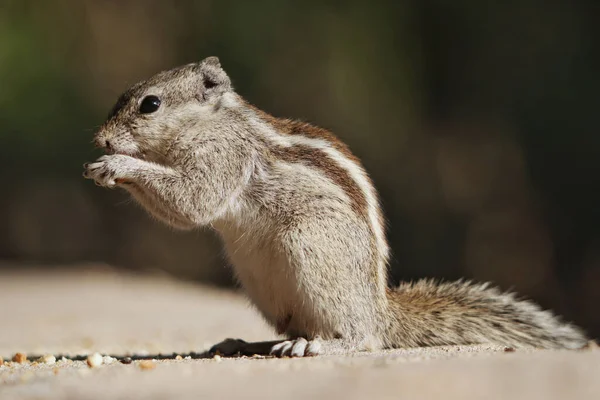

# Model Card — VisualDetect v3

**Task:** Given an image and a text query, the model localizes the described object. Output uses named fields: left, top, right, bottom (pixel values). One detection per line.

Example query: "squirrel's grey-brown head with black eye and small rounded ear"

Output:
left=95, top=57, right=232, bottom=161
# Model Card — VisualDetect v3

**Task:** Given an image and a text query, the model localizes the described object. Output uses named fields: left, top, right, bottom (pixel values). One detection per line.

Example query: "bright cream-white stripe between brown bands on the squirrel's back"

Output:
left=244, top=111, right=389, bottom=270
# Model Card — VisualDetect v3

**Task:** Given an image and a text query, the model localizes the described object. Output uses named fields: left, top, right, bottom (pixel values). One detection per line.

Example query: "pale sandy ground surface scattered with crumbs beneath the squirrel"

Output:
left=0, top=268, right=600, bottom=399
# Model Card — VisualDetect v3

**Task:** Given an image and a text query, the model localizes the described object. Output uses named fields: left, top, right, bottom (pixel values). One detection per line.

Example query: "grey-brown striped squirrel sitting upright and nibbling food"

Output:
left=84, top=57, right=587, bottom=357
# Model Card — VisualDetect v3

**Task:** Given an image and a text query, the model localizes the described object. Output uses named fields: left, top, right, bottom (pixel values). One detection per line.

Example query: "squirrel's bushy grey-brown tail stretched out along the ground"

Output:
left=385, top=280, right=587, bottom=349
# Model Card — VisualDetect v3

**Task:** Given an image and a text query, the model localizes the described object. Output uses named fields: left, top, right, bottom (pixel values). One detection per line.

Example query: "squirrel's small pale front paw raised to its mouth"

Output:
left=83, top=154, right=135, bottom=188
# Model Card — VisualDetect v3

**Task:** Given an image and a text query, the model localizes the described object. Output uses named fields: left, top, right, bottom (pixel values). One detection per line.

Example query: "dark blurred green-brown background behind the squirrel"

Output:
left=0, top=0, right=600, bottom=337
